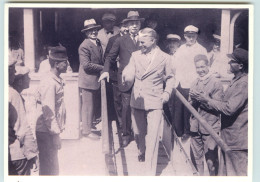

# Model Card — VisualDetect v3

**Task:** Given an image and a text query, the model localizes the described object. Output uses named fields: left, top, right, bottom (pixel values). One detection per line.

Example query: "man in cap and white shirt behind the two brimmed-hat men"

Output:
left=97, top=13, right=120, bottom=51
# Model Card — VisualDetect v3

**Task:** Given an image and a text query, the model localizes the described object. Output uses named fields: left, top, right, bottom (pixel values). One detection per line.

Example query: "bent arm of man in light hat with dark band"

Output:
left=79, top=47, right=103, bottom=73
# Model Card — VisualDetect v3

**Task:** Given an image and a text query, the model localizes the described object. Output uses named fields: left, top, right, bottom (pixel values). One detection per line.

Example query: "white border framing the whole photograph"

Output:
left=4, top=2, right=254, bottom=182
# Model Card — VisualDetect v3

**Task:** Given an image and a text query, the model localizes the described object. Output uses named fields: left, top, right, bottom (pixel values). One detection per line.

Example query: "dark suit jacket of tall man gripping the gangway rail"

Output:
left=103, top=34, right=140, bottom=92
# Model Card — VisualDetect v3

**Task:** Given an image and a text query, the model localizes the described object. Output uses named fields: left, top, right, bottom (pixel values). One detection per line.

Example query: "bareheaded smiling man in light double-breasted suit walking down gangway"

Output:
left=122, top=28, right=175, bottom=175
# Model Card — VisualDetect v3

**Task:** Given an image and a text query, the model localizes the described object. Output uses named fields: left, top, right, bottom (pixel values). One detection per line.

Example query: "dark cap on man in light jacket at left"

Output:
left=49, top=46, right=68, bottom=61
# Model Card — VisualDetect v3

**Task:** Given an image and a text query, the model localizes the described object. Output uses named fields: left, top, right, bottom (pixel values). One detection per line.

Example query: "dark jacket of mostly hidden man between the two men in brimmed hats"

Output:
left=104, top=34, right=121, bottom=82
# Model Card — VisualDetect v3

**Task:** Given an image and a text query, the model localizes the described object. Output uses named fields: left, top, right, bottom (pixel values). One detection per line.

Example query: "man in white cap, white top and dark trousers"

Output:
left=172, top=25, right=207, bottom=141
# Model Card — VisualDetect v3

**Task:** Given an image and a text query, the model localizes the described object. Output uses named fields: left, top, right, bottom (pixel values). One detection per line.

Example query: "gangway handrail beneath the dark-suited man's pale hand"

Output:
left=101, top=80, right=110, bottom=154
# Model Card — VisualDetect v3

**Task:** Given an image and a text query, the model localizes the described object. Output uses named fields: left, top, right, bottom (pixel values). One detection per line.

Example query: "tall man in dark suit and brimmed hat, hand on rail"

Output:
left=99, top=11, right=144, bottom=147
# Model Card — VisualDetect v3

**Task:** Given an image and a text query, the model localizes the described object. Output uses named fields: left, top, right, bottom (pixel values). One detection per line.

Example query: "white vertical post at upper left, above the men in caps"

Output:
left=23, top=9, right=35, bottom=72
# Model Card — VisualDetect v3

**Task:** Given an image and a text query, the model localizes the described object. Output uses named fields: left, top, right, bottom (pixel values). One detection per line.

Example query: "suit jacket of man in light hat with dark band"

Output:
left=78, top=39, right=103, bottom=90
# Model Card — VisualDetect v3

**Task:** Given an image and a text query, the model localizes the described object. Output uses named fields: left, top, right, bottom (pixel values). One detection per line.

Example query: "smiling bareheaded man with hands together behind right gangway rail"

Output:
left=189, top=54, right=223, bottom=176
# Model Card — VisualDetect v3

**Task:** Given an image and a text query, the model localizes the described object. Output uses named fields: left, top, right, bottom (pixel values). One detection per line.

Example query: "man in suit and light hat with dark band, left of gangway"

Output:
left=78, top=19, right=103, bottom=140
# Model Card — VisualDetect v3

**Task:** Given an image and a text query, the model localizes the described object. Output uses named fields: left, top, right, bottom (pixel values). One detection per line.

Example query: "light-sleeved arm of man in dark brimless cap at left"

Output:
left=40, top=81, right=61, bottom=135
